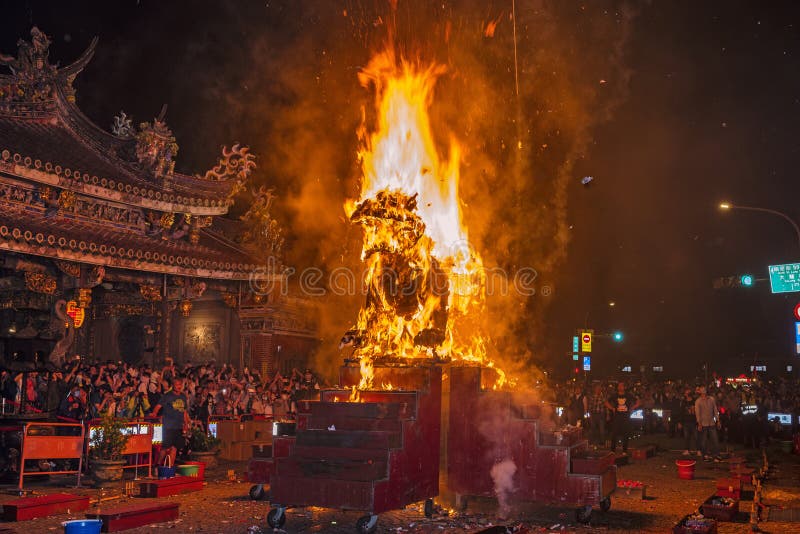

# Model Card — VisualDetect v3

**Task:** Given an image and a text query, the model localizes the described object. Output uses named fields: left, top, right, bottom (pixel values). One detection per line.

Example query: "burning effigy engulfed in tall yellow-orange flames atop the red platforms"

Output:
left=343, top=51, right=505, bottom=397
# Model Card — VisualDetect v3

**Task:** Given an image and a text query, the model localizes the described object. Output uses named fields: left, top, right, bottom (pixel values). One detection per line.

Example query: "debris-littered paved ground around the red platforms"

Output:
left=0, top=436, right=800, bottom=534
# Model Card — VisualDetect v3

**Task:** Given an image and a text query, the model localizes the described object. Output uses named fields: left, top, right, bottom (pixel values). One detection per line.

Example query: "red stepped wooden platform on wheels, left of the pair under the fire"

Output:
left=270, top=365, right=442, bottom=514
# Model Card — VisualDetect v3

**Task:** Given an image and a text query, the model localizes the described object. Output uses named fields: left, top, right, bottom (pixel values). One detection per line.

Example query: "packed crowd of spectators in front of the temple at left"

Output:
left=0, top=358, right=320, bottom=424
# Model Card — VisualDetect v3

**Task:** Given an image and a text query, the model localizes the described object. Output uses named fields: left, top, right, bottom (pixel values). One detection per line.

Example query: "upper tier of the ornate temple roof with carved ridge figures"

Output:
left=0, top=28, right=250, bottom=215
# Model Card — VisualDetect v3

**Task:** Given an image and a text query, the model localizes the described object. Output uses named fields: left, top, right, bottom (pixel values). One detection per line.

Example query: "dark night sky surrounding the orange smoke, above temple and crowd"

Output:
left=0, top=0, right=800, bottom=374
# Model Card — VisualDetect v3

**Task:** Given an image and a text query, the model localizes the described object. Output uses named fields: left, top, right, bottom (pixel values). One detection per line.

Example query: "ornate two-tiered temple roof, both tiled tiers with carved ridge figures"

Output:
left=0, top=28, right=279, bottom=280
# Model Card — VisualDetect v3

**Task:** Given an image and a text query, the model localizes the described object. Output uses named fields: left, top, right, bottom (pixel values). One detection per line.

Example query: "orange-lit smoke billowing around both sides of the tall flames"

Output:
left=78, top=0, right=637, bottom=376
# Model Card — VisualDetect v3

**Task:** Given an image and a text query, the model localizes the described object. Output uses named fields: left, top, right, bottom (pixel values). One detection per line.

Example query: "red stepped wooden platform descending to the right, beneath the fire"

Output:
left=445, top=365, right=617, bottom=507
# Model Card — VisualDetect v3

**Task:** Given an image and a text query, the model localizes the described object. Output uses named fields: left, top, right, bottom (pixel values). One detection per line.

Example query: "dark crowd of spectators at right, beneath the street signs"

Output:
left=555, top=378, right=800, bottom=461
